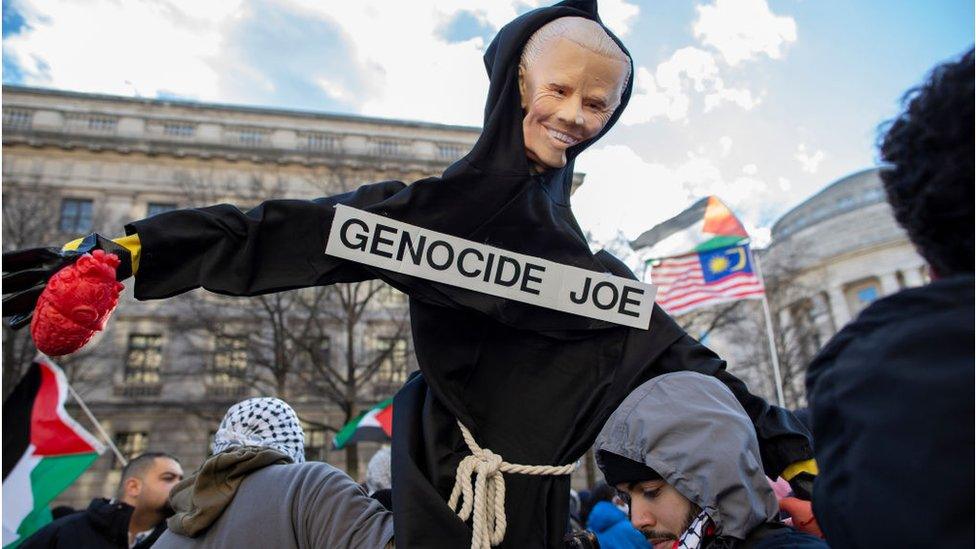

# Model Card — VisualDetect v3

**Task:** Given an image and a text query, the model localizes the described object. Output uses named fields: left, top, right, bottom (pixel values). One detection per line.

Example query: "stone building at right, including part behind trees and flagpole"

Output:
left=692, top=168, right=928, bottom=408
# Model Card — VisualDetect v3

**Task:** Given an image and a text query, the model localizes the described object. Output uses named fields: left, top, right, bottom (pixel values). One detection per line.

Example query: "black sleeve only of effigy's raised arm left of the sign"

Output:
left=126, top=181, right=405, bottom=299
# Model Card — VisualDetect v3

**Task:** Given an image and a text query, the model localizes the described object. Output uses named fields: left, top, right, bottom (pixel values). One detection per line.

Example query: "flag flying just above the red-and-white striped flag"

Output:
left=630, top=196, right=749, bottom=259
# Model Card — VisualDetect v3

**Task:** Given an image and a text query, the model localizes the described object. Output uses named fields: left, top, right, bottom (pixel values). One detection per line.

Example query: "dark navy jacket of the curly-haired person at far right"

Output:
left=807, top=274, right=974, bottom=548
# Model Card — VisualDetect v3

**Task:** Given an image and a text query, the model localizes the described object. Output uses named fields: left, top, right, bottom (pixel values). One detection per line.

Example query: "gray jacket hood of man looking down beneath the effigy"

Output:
left=596, top=372, right=778, bottom=539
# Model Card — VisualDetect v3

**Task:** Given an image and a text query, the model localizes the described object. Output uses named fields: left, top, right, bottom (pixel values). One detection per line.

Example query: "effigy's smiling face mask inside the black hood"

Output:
left=519, top=38, right=629, bottom=170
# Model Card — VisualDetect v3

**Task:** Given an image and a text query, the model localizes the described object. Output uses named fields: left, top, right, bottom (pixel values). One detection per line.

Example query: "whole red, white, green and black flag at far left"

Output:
left=3, top=356, right=104, bottom=548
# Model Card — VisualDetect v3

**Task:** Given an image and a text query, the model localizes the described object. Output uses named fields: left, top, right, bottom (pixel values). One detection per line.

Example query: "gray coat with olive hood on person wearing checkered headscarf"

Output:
left=153, top=448, right=393, bottom=549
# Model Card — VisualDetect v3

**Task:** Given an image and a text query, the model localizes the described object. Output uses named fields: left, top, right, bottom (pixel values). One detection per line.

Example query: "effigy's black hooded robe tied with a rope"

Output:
left=120, top=0, right=812, bottom=548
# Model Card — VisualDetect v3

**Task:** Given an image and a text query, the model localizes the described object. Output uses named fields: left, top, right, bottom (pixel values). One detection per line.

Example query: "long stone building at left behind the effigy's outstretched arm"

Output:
left=2, top=85, right=492, bottom=507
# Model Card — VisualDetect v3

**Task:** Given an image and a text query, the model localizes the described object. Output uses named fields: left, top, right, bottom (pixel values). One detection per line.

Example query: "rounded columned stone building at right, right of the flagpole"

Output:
left=762, top=168, right=928, bottom=359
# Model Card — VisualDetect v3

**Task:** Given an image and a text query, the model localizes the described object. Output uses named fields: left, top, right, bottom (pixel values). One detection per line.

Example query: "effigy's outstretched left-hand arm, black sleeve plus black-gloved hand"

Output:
left=3, top=181, right=405, bottom=331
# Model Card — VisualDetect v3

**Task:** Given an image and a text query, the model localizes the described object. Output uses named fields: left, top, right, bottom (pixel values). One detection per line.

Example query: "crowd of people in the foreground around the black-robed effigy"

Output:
left=11, top=13, right=974, bottom=549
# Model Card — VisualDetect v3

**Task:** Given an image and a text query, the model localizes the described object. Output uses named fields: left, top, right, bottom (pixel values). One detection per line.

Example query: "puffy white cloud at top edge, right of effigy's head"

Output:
left=693, top=0, right=797, bottom=65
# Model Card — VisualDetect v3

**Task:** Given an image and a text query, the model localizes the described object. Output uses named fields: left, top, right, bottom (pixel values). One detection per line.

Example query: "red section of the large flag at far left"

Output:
left=30, top=361, right=97, bottom=456
